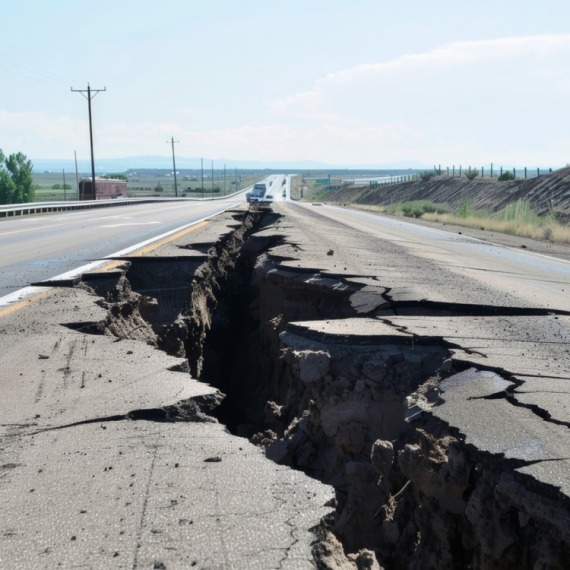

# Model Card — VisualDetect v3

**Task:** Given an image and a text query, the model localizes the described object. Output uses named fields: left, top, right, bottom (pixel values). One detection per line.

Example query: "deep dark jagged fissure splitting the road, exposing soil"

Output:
left=61, top=212, right=570, bottom=570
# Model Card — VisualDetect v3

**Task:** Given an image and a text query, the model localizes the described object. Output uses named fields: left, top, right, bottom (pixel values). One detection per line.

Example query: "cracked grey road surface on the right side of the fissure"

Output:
left=272, top=203, right=570, bottom=497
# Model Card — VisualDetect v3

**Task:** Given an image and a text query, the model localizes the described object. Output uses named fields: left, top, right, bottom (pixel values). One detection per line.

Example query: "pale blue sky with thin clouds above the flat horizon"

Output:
left=0, top=0, right=570, bottom=166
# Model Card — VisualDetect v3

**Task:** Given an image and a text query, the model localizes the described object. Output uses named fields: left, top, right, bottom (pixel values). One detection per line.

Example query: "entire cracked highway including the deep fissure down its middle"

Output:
left=0, top=184, right=570, bottom=570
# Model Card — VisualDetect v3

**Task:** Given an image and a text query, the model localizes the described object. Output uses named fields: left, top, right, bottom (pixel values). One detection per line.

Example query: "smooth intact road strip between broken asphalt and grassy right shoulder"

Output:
left=296, top=205, right=570, bottom=311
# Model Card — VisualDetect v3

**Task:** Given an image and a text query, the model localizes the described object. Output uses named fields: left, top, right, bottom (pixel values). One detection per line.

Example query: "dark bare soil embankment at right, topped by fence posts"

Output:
left=327, top=168, right=570, bottom=223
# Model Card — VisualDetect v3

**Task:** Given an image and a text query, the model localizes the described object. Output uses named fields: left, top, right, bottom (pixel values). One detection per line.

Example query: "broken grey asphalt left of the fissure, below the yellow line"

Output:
left=0, top=207, right=333, bottom=570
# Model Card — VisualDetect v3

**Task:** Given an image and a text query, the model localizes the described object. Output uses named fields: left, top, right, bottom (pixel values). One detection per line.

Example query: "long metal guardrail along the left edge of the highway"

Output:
left=0, top=190, right=248, bottom=218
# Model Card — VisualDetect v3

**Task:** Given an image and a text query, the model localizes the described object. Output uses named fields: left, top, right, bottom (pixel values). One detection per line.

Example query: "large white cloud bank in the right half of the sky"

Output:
left=269, top=34, right=570, bottom=164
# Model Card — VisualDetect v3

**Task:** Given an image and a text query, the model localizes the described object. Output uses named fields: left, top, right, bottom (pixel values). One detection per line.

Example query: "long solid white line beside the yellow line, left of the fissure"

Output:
left=0, top=202, right=237, bottom=307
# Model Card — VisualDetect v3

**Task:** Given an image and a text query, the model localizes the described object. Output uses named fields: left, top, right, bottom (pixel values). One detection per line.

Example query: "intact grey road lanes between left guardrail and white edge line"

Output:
left=0, top=193, right=245, bottom=297
